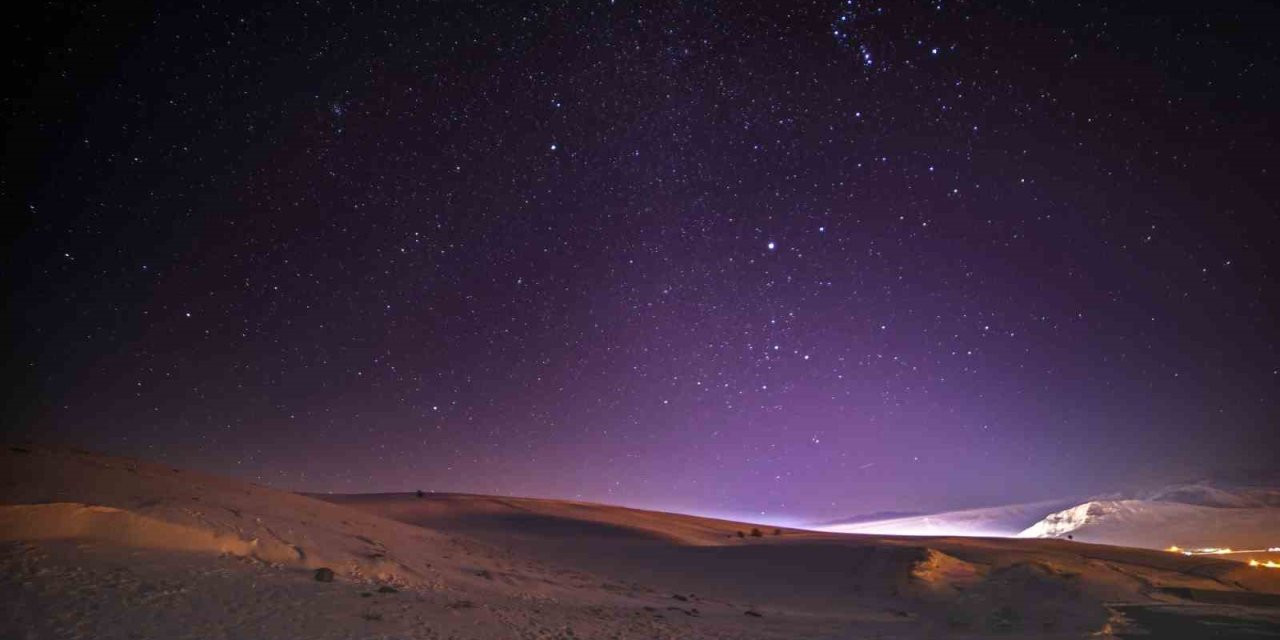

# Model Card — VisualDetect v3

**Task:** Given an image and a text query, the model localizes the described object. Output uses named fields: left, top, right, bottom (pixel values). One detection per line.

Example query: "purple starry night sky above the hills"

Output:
left=0, top=0, right=1280, bottom=521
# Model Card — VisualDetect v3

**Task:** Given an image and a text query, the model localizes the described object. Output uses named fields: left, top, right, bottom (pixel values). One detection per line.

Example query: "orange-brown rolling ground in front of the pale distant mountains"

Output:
left=0, top=445, right=1280, bottom=639
